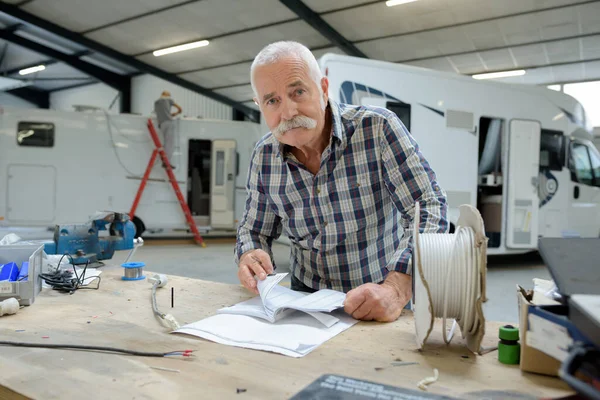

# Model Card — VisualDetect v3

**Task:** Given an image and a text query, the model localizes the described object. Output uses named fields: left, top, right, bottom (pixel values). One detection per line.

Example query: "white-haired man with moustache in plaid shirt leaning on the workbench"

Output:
left=236, top=42, right=448, bottom=321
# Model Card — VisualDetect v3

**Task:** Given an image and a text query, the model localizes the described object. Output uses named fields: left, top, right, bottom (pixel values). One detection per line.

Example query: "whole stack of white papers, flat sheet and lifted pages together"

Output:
left=174, top=274, right=358, bottom=357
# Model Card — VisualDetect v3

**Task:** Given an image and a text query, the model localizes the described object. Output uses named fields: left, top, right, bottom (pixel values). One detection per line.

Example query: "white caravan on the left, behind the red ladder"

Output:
left=0, top=107, right=262, bottom=237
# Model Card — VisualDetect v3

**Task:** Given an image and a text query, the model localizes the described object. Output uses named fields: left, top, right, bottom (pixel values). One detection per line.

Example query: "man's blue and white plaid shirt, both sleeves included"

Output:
left=235, top=100, right=448, bottom=292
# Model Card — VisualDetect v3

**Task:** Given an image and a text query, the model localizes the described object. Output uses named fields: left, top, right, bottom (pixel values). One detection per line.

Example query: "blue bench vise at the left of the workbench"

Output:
left=44, top=212, right=135, bottom=264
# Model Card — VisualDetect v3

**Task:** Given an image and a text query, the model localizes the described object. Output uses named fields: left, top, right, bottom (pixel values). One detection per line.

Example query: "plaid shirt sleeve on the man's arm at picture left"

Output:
left=235, top=147, right=281, bottom=264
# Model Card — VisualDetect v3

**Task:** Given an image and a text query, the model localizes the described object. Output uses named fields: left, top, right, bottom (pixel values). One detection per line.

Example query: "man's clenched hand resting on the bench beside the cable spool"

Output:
left=344, top=271, right=412, bottom=322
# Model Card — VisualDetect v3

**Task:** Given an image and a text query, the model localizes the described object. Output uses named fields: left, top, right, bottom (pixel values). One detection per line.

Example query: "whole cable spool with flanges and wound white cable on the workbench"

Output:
left=413, top=203, right=487, bottom=353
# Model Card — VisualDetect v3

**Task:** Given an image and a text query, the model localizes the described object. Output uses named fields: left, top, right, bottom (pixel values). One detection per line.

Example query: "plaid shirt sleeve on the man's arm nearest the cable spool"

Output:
left=380, top=113, right=449, bottom=274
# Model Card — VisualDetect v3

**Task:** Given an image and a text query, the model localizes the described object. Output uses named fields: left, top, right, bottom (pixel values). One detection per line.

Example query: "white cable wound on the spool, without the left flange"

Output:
left=419, top=227, right=479, bottom=343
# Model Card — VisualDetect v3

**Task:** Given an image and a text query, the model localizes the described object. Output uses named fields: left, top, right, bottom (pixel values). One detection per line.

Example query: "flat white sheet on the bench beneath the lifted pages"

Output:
left=174, top=311, right=358, bottom=357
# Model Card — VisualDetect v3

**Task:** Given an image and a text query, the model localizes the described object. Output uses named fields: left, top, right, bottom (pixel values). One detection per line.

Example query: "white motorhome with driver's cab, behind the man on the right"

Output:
left=319, top=54, right=600, bottom=254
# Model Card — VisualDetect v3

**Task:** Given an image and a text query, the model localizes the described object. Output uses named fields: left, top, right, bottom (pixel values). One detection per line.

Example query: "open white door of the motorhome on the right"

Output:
left=506, top=120, right=541, bottom=249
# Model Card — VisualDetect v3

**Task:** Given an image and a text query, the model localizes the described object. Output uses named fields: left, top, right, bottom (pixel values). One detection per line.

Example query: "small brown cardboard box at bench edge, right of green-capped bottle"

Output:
left=517, top=285, right=561, bottom=376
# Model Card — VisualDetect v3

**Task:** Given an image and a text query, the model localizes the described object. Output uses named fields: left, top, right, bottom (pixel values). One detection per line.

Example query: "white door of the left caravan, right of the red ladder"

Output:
left=210, top=140, right=236, bottom=229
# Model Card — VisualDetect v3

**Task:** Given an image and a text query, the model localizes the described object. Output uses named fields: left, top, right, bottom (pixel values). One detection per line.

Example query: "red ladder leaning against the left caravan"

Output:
left=129, top=118, right=206, bottom=247
